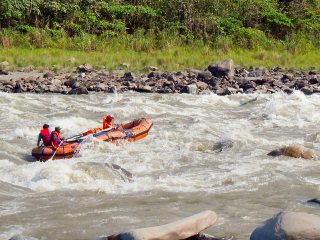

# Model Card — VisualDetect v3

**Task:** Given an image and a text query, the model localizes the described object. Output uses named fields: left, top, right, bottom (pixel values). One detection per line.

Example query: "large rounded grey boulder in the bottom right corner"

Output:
left=250, top=212, right=320, bottom=240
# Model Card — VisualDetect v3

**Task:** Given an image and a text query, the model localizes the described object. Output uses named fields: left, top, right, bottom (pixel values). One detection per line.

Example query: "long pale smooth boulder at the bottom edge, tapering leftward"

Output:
left=107, top=210, right=218, bottom=240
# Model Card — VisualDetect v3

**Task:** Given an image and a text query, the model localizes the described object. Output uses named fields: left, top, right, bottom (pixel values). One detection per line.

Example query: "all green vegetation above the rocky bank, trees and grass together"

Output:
left=0, top=0, right=320, bottom=70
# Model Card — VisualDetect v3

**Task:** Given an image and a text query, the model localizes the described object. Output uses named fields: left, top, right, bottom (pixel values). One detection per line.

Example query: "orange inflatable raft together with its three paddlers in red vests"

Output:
left=32, top=115, right=153, bottom=161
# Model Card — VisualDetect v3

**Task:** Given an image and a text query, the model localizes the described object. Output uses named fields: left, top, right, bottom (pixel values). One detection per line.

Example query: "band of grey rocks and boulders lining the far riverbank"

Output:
left=0, top=60, right=320, bottom=95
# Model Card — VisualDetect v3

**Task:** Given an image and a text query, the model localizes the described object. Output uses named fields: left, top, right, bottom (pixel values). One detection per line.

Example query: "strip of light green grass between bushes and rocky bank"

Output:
left=0, top=45, right=320, bottom=72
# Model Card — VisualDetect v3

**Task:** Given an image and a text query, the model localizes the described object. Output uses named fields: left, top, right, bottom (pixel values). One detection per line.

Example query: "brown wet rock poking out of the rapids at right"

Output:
left=268, top=146, right=314, bottom=159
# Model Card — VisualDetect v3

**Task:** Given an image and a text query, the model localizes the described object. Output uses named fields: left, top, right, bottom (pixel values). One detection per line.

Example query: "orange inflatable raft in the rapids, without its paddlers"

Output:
left=32, top=118, right=153, bottom=161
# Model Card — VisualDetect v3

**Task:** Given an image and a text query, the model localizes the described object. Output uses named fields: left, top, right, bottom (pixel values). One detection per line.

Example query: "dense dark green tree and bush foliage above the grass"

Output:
left=0, top=0, right=320, bottom=47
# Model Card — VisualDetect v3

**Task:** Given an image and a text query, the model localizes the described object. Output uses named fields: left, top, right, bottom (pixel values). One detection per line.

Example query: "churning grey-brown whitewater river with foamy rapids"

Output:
left=0, top=91, right=320, bottom=240
